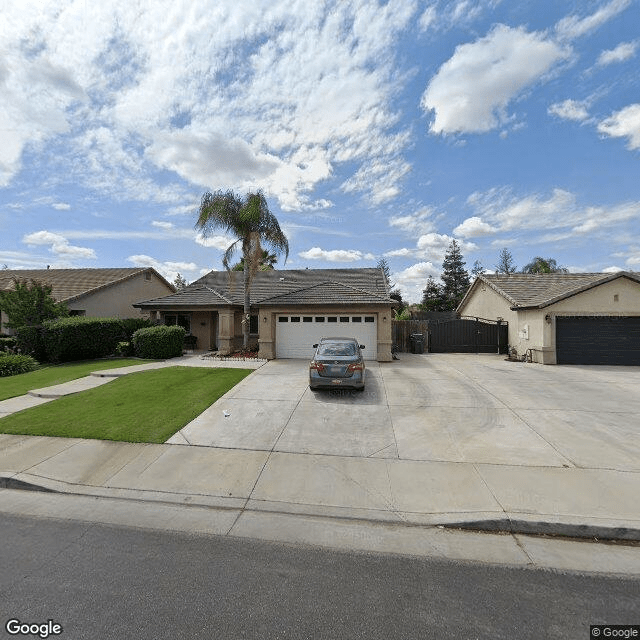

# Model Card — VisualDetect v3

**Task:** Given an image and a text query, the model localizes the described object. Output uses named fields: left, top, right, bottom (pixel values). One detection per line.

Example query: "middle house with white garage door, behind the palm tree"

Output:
left=134, top=268, right=395, bottom=361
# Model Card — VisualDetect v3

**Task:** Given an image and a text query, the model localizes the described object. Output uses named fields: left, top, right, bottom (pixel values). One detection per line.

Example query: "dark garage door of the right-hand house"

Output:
left=556, top=316, right=640, bottom=365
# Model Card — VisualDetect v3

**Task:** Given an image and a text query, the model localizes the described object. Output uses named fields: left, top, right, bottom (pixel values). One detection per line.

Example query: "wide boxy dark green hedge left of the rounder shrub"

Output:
left=42, top=316, right=125, bottom=362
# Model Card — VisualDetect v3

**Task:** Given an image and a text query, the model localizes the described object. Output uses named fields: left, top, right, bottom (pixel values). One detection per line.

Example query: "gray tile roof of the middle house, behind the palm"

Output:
left=134, top=268, right=395, bottom=308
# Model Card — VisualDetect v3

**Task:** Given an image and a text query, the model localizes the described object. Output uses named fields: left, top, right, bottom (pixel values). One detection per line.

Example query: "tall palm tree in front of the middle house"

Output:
left=195, top=190, right=289, bottom=349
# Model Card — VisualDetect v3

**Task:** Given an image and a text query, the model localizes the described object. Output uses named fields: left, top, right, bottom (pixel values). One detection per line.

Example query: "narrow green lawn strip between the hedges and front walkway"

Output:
left=0, top=358, right=153, bottom=400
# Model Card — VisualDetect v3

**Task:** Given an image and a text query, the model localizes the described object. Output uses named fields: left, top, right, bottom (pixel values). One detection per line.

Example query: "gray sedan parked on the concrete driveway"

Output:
left=309, top=338, right=366, bottom=390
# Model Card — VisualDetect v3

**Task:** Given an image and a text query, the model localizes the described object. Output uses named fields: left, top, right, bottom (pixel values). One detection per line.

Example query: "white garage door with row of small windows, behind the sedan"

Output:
left=276, top=314, right=378, bottom=360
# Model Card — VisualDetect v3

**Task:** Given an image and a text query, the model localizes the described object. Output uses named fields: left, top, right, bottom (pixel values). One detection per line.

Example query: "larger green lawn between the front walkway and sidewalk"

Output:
left=0, top=367, right=253, bottom=443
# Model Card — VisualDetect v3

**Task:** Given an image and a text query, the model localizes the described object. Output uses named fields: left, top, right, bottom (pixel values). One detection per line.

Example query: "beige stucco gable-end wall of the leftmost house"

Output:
left=67, top=272, right=173, bottom=318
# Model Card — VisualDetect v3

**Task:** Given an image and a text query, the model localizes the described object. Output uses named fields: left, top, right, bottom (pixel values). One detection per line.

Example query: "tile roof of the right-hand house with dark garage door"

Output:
left=457, top=271, right=640, bottom=312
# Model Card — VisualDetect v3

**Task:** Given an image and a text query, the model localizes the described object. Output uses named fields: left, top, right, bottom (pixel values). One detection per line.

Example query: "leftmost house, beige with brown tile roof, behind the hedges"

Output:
left=0, top=267, right=176, bottom=332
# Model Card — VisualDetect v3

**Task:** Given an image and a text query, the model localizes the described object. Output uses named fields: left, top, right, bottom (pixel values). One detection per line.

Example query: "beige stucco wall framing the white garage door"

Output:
left=258, top=305, right=393, bottom=362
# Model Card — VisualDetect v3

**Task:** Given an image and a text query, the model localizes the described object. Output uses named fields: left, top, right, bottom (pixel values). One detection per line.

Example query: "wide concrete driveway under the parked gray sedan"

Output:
left=168, top=354, right=640, bottom=471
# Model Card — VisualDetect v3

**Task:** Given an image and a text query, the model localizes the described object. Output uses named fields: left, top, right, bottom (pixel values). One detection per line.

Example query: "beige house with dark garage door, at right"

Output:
left=457, top=271, right=640, bottom=365
